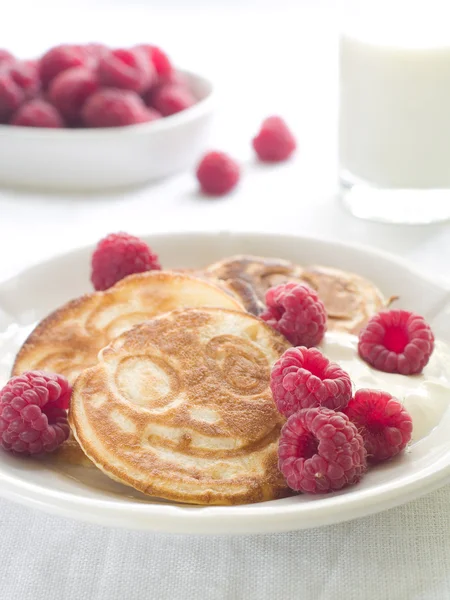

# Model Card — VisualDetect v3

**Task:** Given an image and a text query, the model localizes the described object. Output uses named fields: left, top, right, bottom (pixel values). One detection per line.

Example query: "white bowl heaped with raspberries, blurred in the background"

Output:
left=0, top=44, right=213, bottom=191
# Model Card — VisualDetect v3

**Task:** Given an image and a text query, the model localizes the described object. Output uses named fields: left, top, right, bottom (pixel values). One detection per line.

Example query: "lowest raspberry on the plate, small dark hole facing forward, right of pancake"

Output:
left=278, top=408, right=367, bottom=494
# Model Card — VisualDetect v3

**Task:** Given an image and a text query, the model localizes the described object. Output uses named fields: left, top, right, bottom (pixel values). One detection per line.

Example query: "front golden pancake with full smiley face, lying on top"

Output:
left=69, top=308, right=289, bottom=504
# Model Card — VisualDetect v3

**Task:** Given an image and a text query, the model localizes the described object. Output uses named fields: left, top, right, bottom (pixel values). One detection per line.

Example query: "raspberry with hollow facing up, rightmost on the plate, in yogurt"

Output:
left=358, top=310, right=434, bottom=375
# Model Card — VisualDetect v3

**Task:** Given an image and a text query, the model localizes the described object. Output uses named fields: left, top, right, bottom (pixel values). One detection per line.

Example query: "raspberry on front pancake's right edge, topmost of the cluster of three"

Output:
left=270, top=347, right=352, bottom=417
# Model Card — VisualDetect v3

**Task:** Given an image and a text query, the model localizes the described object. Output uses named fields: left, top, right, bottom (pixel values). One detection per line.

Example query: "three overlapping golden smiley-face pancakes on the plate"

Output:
left=13, top=256, right=385, bottom=504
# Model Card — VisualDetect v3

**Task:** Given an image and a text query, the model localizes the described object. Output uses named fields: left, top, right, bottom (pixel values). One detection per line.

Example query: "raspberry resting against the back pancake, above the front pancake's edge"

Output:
left=260, top=282, right=327, bottom=348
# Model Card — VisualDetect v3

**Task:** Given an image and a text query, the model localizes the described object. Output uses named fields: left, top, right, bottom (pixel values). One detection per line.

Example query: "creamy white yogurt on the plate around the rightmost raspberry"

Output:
left=319, top=332, right=450, bottom=442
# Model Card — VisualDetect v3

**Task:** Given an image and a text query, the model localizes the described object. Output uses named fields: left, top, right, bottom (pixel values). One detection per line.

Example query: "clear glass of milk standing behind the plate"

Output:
left=339, top=0, right=450, bottom=223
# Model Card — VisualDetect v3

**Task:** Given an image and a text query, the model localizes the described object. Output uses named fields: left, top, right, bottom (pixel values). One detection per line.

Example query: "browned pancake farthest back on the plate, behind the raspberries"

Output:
left=205, top=255, right=387, bottom=334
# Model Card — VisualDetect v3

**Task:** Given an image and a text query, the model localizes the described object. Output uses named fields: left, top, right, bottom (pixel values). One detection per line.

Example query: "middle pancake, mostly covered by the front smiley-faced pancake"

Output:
left=12, top=271, right=242, bottom=465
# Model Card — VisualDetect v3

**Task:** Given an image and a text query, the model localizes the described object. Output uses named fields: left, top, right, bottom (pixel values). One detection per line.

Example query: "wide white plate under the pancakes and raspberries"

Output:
left=0, top=233, right=450, bottom=534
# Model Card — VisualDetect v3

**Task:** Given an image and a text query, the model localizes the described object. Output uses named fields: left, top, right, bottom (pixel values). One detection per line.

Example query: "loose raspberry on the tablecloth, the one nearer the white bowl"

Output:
left=196, top=152, right=240, bottom=196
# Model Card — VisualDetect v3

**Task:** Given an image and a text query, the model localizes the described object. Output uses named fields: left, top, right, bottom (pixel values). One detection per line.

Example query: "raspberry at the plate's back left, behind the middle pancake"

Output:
left=91, top=233, right=161, bottom=290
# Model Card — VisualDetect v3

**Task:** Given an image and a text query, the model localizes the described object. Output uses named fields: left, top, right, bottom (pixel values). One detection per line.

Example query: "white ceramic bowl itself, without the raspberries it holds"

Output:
left=0, top=71, right=213, bottom=191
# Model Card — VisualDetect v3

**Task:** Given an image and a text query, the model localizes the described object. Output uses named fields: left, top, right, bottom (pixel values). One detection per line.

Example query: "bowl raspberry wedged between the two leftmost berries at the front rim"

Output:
left=48, top=67, right=98, bottom=121
